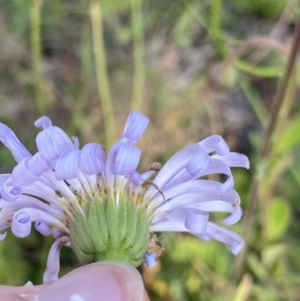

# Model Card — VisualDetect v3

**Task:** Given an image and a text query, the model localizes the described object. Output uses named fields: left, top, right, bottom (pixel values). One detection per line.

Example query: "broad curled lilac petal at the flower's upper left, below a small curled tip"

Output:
left=36, top=126, right=77, bottom=161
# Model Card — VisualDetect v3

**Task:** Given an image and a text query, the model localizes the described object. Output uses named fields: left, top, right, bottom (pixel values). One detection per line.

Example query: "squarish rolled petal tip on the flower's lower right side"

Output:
left=185, top=209, right=209, bottom=234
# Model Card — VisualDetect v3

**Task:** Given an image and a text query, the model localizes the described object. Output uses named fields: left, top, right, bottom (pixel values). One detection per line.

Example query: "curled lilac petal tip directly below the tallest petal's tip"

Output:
left=112, top=143, right=141, bottom=176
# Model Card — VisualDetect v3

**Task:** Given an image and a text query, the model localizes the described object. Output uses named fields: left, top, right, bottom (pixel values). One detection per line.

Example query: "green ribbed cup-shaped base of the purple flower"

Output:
left=68, top=194, right=150, bottom=266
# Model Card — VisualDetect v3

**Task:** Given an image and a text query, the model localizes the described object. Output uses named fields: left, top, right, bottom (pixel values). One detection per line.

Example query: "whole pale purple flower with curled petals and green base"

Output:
left=0, top=111, right=249, bottom=282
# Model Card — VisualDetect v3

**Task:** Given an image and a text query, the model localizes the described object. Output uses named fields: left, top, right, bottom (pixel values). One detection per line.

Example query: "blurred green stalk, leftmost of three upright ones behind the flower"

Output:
left=30, top=0, right=46, bottom=114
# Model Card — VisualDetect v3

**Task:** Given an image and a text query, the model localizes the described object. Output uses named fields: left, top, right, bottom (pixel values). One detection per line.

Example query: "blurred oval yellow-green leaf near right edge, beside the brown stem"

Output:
left=266, top=198, right=291, bottom=240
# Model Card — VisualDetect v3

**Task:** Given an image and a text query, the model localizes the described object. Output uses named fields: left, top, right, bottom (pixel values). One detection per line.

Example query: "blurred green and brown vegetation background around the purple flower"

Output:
left=0, top=0, right=300, bottom=301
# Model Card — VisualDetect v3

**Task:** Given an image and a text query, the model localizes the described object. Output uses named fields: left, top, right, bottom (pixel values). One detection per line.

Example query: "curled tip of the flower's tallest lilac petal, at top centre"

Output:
left=123, top=111, right=149, bottom=143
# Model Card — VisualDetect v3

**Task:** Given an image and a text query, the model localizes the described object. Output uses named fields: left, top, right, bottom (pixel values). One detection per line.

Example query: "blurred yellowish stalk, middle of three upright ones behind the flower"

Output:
left=90, top=1, right=116, bottom=147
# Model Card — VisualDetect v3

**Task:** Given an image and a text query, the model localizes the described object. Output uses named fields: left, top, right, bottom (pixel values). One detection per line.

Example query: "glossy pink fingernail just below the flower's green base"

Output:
left=33, top=262, right=149, bottom=301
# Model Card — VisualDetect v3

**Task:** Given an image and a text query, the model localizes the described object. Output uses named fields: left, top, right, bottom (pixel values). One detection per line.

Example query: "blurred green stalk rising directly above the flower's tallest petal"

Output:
left=131, top=0, right=145, bottom=111
